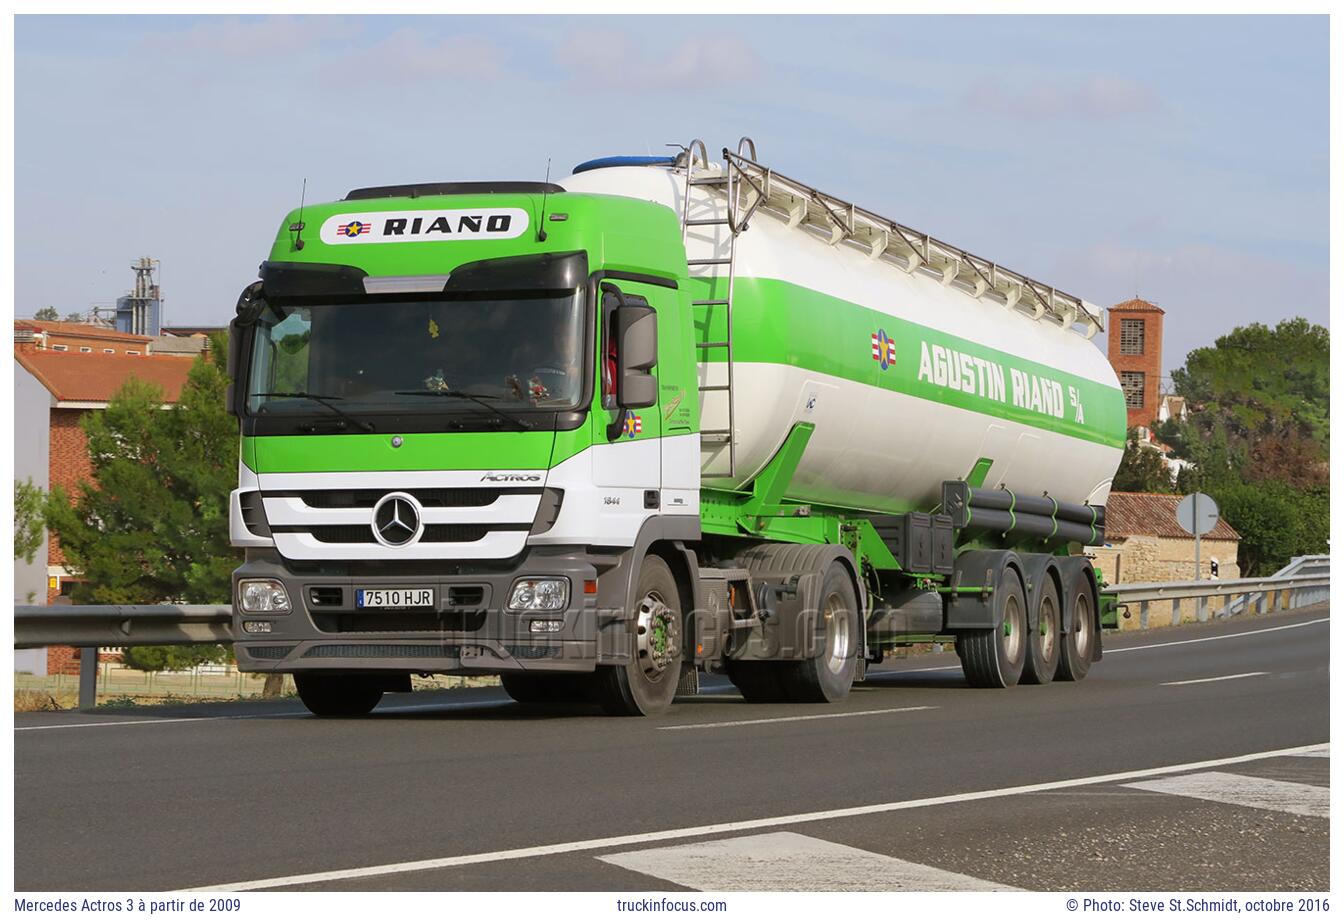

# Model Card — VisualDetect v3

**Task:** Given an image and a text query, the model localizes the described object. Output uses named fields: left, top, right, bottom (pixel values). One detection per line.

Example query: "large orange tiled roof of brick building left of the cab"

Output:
left=13, top=352, right=192, bottom=403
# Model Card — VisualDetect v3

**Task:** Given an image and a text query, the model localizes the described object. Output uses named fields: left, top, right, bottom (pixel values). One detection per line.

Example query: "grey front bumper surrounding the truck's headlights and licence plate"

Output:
left=234, top=549, right=599, bottom=674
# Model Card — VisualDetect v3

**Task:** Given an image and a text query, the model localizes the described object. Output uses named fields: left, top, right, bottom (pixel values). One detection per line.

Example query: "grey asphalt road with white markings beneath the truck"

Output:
left=15, top=606, right=1329, bottom=892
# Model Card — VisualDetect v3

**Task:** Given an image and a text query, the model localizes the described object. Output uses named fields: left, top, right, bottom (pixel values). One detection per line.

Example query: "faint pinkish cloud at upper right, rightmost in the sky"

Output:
left=961, top=74, right=1164, bottom=120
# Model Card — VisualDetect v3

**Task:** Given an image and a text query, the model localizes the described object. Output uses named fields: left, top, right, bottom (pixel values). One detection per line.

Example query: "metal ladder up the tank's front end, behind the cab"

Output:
left=681, top=137, right=765, bottom=478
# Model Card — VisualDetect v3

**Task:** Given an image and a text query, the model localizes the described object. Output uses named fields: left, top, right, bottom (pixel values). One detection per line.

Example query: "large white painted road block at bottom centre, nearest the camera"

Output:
left=597, top=831, right=1020, bottom=892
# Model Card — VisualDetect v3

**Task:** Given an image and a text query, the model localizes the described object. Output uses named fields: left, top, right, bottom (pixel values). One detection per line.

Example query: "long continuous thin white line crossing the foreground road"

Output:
left=190, top=741, right=1320, bottom=892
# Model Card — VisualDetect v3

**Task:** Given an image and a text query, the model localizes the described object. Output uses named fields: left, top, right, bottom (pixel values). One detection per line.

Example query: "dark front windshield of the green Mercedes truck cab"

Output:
left=247, top=291, right=583, bottom=416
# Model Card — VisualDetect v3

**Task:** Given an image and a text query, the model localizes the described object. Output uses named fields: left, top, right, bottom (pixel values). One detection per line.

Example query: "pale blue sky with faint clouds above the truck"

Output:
left=15, top=15, right=1329, bottom=371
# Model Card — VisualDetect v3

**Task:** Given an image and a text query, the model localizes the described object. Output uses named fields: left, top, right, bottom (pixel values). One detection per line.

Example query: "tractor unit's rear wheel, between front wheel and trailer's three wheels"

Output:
left=781, top=563, right=862, bottom=702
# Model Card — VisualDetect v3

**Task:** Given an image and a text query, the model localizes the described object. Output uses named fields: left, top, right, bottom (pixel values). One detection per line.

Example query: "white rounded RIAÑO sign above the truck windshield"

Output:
left=319, top=208, right=530, bottom=246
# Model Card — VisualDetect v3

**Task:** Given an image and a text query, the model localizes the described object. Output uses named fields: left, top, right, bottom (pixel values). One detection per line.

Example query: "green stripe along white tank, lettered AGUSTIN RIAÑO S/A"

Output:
left=695, top=278, right=1125, bottom=450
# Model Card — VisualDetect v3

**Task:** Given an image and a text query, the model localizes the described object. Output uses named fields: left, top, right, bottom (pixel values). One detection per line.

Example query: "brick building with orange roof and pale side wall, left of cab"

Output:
left=13, top=331, right=192, bottom=673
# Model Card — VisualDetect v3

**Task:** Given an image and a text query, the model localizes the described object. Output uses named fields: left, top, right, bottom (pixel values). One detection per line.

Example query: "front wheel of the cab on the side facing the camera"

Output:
left=594, top=556, right=681, bottom=716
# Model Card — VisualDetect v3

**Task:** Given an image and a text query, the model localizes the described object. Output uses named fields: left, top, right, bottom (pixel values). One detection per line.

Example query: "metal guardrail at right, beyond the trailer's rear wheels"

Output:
left=1102, top=556, right=1331, bottom=629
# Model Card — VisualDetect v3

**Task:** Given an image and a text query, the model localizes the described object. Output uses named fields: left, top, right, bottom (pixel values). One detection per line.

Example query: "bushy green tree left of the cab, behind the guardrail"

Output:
left=47, top=341, right=241, bottom=666
